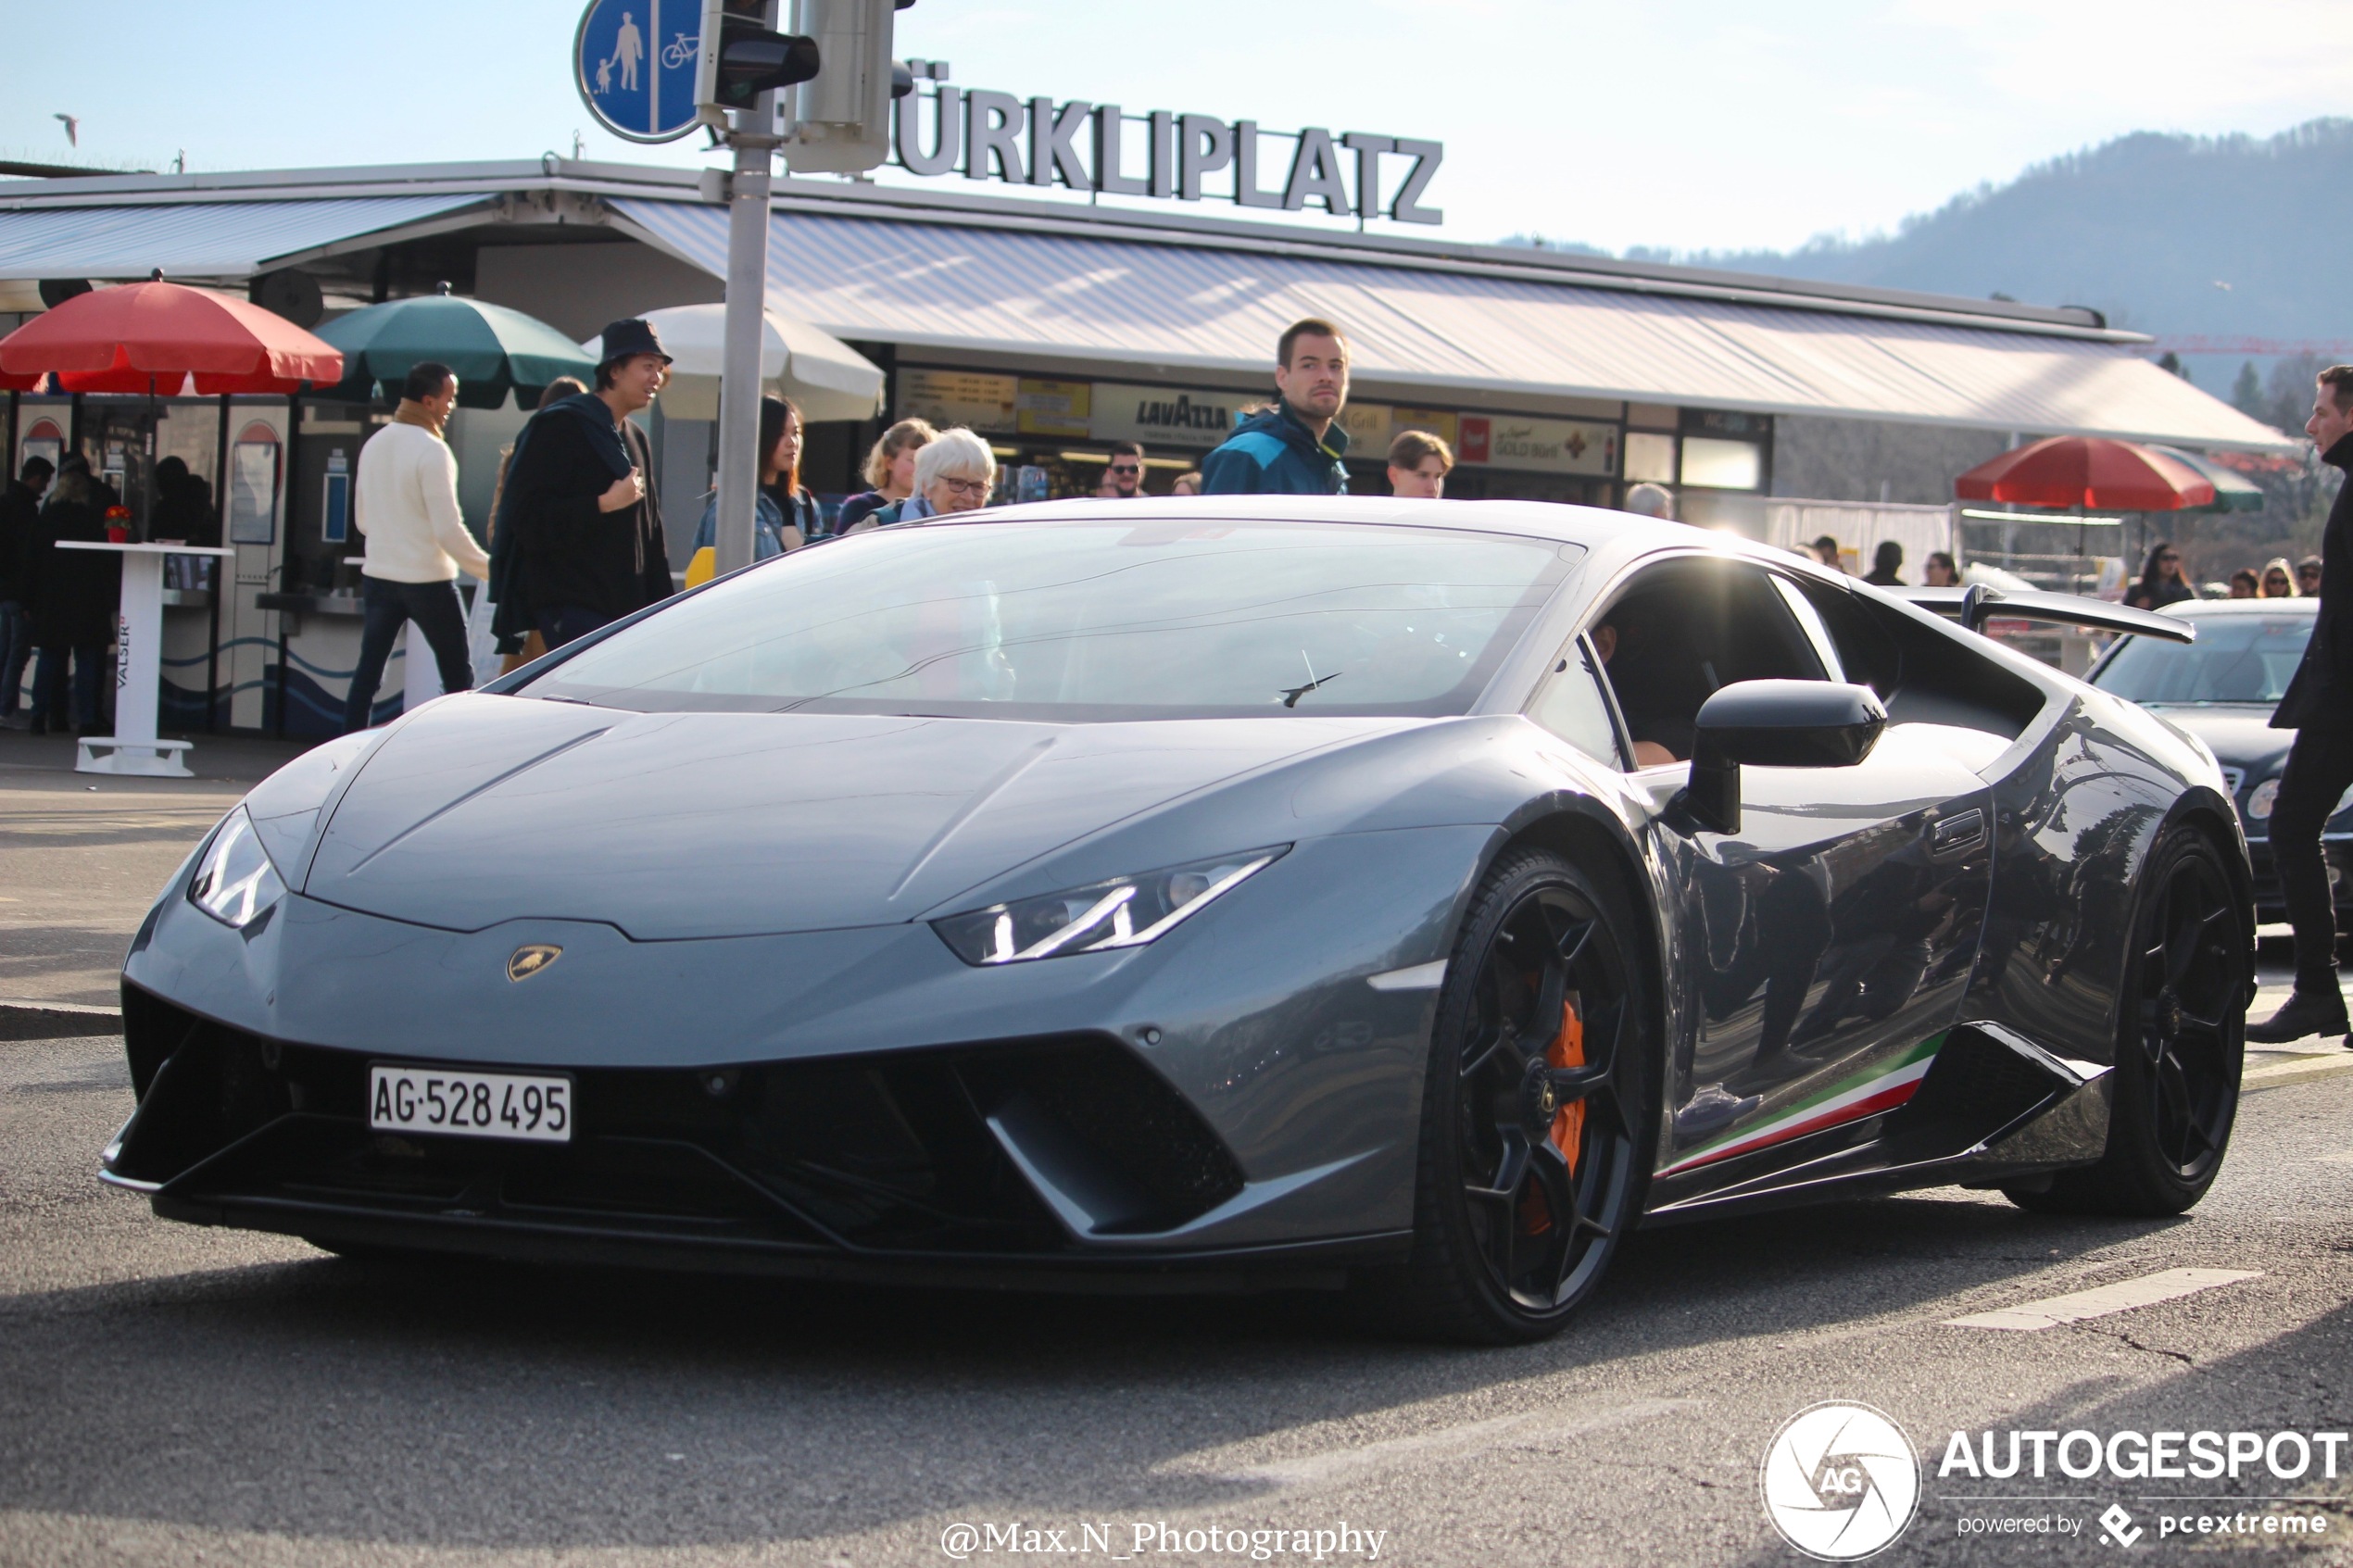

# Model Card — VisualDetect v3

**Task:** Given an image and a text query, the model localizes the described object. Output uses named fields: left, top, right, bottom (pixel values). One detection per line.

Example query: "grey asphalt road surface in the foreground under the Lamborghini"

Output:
left=0, top=1039, right=2353, bottom=1568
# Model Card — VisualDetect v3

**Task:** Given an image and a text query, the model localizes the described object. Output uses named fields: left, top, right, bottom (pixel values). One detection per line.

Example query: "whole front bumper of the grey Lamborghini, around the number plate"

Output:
left=106, top=827, right=1490, bottom=1284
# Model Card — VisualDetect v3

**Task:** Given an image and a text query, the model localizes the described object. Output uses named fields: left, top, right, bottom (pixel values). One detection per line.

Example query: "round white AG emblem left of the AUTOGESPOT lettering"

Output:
left=1757, top=1401, right=1920, bottom=1563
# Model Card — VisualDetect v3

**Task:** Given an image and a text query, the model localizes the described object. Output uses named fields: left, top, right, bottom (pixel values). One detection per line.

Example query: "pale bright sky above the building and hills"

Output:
left=0, top=0, right=2353, bottom=252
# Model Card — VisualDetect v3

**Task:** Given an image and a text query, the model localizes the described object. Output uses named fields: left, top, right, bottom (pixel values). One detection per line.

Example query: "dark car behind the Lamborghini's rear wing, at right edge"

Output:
left=2087, top=599, right=2353, bottom=924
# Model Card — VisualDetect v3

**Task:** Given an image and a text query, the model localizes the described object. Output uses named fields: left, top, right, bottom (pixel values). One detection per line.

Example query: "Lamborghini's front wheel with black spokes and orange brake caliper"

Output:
left=1390, top=848, right=1655, bottom=1345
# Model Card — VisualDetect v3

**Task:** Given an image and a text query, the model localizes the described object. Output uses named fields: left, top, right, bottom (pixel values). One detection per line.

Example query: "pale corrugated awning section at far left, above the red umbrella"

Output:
left=0, top=193, right=484, bottom=280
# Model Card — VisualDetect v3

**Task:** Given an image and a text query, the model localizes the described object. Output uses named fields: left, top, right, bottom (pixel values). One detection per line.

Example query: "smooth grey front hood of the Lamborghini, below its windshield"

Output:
left=301, top=696, right=1415, bottom=940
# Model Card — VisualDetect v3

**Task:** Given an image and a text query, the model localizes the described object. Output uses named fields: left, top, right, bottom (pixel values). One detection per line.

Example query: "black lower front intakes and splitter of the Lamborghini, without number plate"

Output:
left=106, top=987, right=1395, bottom=1288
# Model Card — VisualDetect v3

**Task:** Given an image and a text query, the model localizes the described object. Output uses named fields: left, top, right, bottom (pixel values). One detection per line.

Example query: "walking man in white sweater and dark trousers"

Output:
left=344, top=359, right=489, bottom=734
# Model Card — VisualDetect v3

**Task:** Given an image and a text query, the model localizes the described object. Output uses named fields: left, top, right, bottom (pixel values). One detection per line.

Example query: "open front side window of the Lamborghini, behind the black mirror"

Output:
left=1586, top=558, right=1829, bottom=766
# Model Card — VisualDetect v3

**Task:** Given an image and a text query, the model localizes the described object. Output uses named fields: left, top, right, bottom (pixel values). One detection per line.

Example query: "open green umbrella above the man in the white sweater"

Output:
left=318, top=284, right=596, bottom=409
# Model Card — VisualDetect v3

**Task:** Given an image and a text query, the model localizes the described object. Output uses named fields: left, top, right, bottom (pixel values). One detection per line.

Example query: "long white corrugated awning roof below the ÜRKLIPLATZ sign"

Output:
left=611, top=197, right=2283, bottom=449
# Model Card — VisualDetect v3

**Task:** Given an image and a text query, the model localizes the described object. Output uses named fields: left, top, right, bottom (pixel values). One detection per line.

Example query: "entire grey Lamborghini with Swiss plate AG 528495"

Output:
left=106, top=498, right=2254, bottom=1340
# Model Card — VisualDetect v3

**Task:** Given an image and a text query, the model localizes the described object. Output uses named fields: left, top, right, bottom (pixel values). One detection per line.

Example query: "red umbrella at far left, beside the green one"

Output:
left=0, top=278, right=344, bottom=397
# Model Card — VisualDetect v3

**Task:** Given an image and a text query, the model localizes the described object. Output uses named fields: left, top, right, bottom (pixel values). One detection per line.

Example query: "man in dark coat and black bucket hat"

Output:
left=497, top=320, right=671, bottom=649
